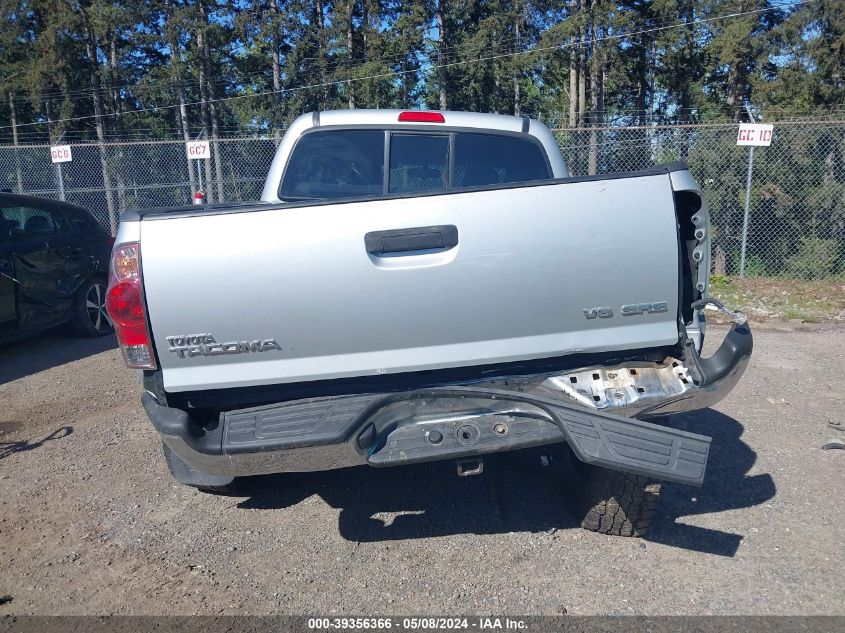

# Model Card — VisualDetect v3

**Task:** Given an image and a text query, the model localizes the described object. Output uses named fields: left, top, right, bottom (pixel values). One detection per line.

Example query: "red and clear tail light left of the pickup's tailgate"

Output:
left=106, top=242, right=156, bottom=369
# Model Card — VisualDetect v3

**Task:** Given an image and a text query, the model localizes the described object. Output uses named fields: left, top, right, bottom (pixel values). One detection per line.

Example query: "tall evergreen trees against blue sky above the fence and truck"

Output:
left=0, top=0, right=845, bottom=143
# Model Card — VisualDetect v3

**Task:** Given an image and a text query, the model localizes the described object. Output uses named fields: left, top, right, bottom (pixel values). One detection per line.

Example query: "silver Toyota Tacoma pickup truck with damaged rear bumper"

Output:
left=107, top=110, right=752, bottom=535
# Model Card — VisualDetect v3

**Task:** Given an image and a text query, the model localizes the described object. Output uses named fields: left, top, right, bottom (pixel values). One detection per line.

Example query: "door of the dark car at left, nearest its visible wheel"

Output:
left=3, top=206, right=73, bottom=330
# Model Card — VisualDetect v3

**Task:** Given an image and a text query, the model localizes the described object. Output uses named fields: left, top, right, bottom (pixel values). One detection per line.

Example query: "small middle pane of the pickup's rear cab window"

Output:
left=388, top=134, right=449, bottom=193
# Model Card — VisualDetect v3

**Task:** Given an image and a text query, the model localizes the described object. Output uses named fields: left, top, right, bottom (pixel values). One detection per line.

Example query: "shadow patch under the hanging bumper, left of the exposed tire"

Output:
left=239, top=449, right=577, bottom=542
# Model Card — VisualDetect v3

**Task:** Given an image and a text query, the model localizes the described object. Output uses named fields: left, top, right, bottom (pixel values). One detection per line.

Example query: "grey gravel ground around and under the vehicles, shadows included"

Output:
left=0, top=324, right=845, bottom=615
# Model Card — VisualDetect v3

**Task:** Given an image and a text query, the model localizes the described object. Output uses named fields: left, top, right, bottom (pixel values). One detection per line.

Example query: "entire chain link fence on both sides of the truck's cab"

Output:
left=0, top=121, right=845, bottom=279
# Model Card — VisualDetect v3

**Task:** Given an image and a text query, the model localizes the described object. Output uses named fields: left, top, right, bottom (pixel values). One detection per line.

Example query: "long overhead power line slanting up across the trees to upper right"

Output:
left=0, top=0, right=810, bottom=130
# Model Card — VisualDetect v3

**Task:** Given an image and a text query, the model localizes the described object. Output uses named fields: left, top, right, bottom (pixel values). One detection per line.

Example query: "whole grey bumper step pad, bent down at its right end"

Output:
left=195, top=387, right=710, bottom=486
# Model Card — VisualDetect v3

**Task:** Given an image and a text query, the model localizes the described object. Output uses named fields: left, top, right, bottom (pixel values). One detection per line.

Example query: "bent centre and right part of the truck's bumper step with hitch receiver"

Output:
left=367, top=386, right=710, bottom=486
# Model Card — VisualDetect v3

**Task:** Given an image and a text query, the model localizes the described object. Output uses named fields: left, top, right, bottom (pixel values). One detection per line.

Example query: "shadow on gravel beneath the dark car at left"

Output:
left=0, top=328, right=117, bottom=385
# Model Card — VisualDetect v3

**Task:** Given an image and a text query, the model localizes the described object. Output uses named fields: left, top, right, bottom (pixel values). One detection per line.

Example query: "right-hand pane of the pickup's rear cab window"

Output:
left=453, top=133, right=551, bottom=187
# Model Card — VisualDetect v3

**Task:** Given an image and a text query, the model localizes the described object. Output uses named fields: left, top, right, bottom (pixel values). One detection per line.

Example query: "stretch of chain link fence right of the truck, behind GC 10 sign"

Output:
left=555, top=121, right=845, bottom=280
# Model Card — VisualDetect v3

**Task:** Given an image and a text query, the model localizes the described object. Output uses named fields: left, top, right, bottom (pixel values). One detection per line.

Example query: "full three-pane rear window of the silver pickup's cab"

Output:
left=279, top=128, right=552, bottom=201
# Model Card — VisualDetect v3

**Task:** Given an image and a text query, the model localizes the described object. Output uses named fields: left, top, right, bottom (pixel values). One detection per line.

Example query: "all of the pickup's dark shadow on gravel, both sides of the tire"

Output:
left=238, top=409, right=775, bottom=556
